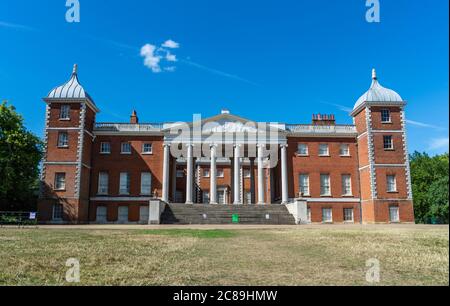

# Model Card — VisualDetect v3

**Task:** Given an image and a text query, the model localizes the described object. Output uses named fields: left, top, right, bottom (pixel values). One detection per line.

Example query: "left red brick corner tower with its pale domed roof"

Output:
left=38, top=65, right=99, bottom=223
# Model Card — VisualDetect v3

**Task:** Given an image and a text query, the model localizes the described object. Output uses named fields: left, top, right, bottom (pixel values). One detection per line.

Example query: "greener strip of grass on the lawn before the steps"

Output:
left=138, top=229, right=237, bottom=239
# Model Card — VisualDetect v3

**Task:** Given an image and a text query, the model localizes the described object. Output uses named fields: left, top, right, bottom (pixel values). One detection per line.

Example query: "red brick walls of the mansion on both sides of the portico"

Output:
left=38, top=66, right=414, bottom=223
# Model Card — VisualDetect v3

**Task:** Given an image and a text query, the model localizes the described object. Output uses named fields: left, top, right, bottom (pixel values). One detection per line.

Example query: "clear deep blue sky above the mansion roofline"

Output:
left=0, top=0, right=449, bottom=154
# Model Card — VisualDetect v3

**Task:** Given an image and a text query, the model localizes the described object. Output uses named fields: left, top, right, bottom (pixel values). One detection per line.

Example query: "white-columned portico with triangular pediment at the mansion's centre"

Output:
left=162, top=111, right=289, bottom=205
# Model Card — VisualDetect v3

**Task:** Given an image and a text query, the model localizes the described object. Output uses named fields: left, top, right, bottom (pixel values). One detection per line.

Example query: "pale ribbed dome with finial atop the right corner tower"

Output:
left=352, top=69, right=405, bottom=114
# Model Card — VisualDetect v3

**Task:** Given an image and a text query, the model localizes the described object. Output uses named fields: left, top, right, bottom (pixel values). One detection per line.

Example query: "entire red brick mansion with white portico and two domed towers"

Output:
left=38, top=66, right=414, bottom=224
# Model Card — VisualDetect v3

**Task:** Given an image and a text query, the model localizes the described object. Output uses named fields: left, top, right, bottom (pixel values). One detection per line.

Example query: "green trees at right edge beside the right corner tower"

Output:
left=410, top=152, right=449, bottom=223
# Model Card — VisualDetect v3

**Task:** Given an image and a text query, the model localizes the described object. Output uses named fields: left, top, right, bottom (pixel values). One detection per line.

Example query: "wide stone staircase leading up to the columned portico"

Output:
left=161, top=204, right=295, bottom=224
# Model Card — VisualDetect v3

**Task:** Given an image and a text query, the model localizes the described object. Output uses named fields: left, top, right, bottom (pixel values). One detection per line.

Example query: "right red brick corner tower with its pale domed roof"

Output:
left=351, top=69, right=414, bottom=223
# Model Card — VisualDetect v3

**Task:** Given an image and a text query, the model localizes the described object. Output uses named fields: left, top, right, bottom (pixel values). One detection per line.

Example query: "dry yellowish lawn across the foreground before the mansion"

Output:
left=0, top=227, right=449, bottom=286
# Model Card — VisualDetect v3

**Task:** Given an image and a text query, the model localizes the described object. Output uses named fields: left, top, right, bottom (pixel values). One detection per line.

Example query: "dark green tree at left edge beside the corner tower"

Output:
left=0, top=101, right=43, bottom=210
